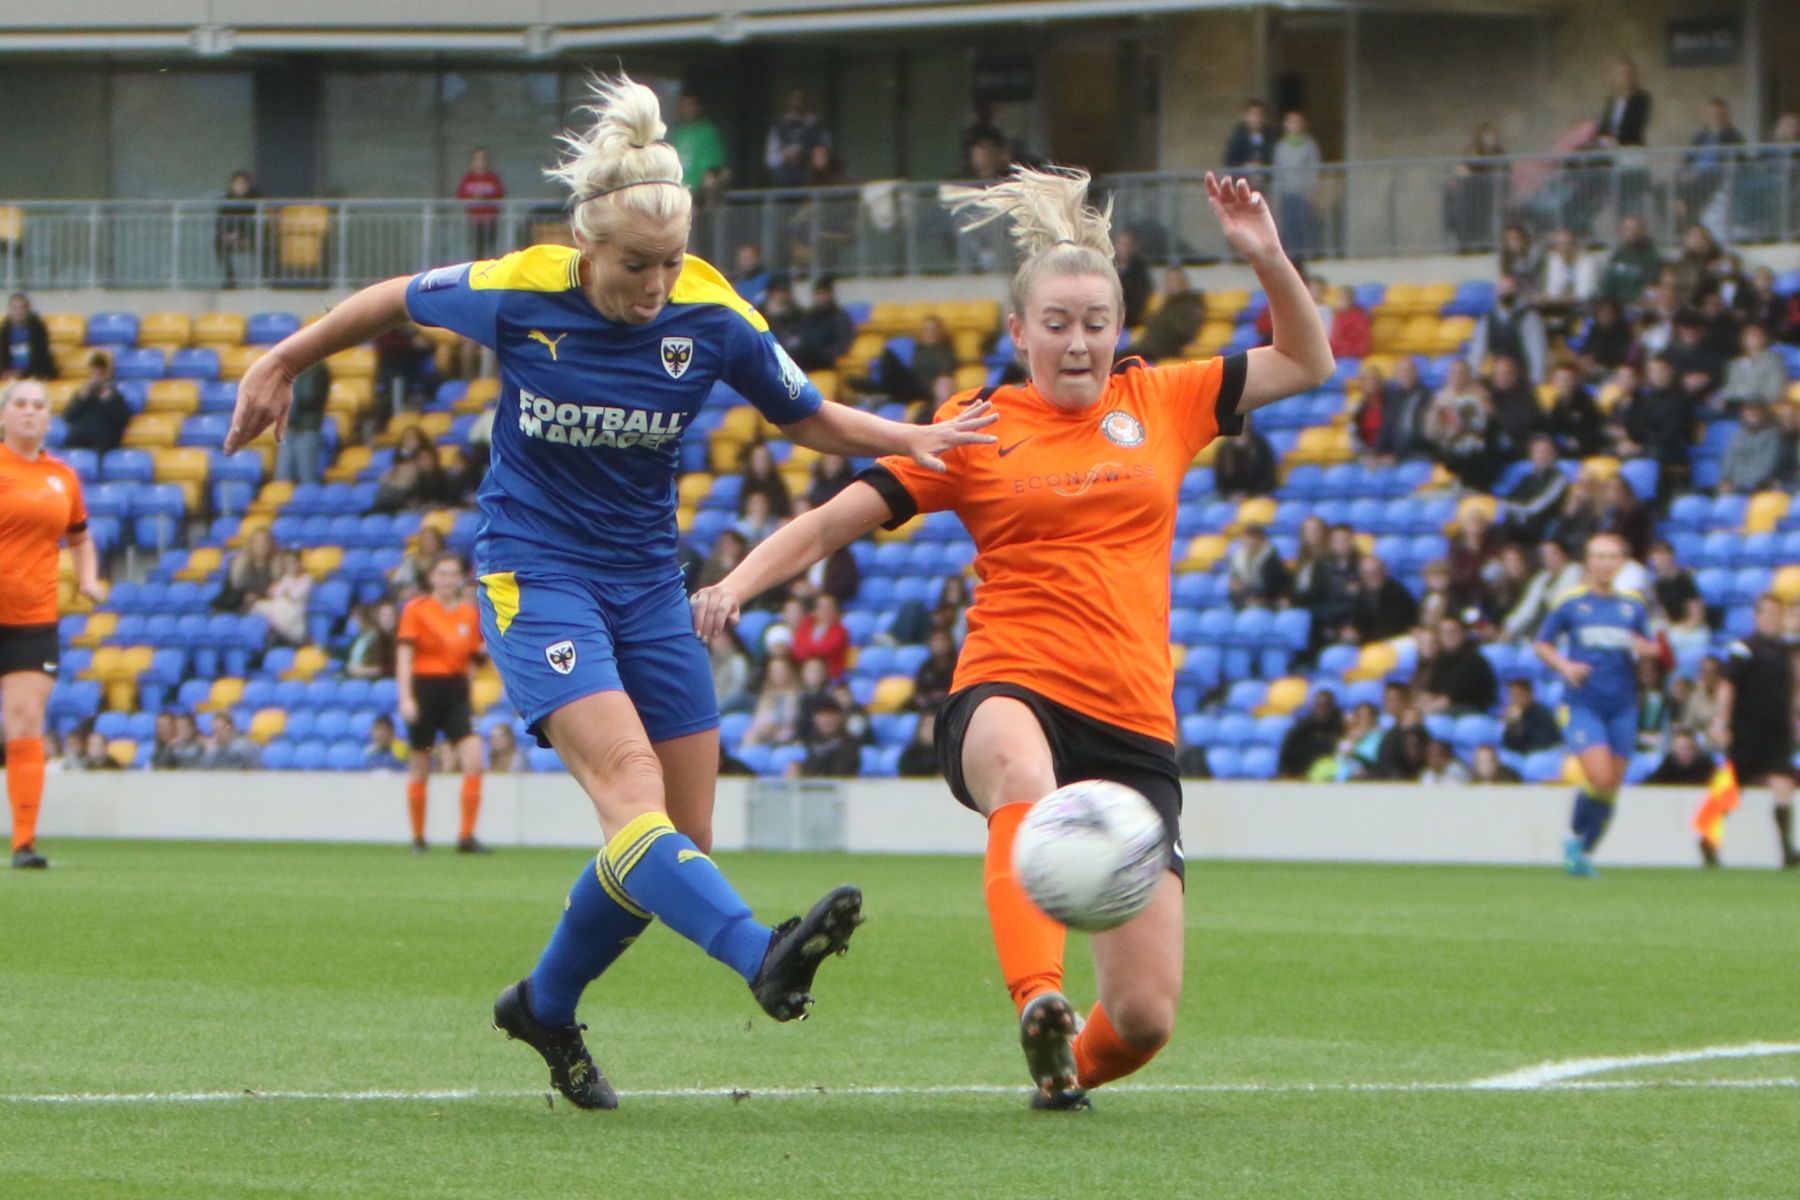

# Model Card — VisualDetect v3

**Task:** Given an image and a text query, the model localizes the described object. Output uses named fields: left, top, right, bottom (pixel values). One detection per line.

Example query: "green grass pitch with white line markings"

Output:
left=0, top=840, right=1800, bottom=1200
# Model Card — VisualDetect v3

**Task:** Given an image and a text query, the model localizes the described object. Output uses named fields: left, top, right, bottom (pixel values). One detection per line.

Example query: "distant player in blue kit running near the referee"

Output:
left=1534, top=533, right=1658, bottom=876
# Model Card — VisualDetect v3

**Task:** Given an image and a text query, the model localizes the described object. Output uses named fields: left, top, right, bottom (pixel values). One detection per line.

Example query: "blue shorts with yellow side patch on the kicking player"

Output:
left=477, top=570, right=718, bottom=747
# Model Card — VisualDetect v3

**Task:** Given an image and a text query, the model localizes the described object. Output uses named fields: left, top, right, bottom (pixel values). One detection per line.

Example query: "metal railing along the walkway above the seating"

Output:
left=0, top=144, right=1800, bottom=290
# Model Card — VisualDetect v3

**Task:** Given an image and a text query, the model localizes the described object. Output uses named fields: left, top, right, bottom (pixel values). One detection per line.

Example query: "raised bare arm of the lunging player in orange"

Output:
left=1206, top=171, right=1337, bottom=412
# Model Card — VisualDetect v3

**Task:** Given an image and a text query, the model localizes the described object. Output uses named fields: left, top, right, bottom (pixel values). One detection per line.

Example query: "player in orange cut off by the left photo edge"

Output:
left=0, top=380, right=101, bottom=867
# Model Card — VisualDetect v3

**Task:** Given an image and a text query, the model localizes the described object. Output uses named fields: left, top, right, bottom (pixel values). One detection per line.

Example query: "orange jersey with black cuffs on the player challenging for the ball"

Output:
left=864, top=354, right=1247, bottom=743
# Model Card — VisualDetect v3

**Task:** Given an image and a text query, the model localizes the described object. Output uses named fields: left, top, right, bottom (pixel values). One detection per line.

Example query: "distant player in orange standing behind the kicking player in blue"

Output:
left=394, top=554, right=488, bottom=855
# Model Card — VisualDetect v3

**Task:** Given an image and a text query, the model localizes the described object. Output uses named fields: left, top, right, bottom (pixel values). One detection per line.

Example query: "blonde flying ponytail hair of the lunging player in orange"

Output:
left=938, top=167, right=1125, bottom=320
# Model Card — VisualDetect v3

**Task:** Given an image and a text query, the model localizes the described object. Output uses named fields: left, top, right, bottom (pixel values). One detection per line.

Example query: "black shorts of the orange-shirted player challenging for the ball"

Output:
left=938, top=684, right=1188, bottom=882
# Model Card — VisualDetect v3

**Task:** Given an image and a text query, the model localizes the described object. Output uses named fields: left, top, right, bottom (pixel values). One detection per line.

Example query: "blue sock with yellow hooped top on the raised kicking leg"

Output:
left=599, top=813, right=770, bottom=982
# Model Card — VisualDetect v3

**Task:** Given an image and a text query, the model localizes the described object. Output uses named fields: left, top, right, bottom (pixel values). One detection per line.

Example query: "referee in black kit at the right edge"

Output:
left=1710, top=596, right=1800, bottom=867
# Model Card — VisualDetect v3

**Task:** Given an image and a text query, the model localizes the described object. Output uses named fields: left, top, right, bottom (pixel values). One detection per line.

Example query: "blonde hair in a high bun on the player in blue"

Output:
left=544, top=76, right=693, bottom=241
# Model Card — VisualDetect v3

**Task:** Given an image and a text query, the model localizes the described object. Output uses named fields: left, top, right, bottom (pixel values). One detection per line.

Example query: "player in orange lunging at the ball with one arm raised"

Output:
left=693, top=171, right=1334, bottom=1108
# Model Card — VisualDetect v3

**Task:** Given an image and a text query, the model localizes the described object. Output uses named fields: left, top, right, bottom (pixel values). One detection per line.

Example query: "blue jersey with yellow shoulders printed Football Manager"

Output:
left=407, top=246, right=823, bottom=581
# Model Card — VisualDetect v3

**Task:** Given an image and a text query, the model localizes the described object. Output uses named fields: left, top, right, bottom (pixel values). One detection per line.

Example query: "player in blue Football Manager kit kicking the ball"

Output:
left=225, top=77, right=994, bottom=1108
